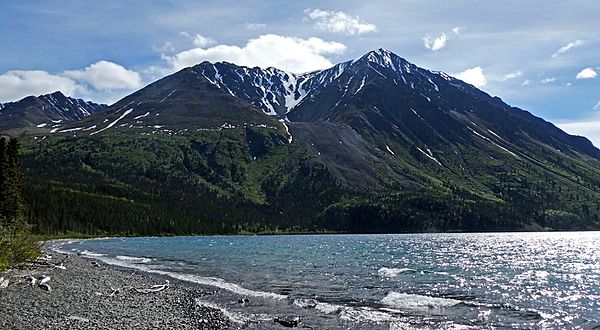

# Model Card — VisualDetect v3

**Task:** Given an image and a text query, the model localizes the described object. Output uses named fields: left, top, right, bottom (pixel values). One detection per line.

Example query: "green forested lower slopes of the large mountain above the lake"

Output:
left=15, top=127, right=600, bottom=240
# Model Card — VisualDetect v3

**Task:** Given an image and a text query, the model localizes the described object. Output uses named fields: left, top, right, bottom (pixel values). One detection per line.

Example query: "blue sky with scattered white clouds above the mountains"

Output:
left=0, top=0, right=600, bottom=146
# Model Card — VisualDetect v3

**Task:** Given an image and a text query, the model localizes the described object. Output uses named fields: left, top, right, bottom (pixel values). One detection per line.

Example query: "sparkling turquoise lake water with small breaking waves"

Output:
left=55, top=232, right=600, bottom=329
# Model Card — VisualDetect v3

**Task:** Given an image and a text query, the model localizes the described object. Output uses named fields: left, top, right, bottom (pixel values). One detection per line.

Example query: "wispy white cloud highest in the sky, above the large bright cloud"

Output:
left=304, top=9, right=377, bottom=35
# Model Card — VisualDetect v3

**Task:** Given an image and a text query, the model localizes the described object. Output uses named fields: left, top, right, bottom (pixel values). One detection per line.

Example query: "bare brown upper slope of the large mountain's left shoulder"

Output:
left=61, top=63, right=283, bottom=135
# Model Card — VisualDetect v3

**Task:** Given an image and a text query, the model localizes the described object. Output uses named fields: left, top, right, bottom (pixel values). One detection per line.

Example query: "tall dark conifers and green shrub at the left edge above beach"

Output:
left=0, top=137, right=39, bottom=271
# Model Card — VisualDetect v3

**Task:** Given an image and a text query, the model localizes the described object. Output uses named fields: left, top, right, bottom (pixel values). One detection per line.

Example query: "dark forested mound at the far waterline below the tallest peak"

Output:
left=320, top=191, right=531, bottom=233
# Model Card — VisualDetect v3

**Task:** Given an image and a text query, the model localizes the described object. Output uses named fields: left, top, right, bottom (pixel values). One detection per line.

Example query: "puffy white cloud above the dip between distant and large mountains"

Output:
left=64, top=61, right=142, bottom=90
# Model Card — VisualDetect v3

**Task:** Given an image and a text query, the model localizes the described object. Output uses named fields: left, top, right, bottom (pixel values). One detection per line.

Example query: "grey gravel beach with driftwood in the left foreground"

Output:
left=0, top=248, right=236, bottom=329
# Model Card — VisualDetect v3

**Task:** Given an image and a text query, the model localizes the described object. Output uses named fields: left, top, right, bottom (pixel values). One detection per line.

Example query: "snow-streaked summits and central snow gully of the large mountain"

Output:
left=180, top=48, right=463, bottom=118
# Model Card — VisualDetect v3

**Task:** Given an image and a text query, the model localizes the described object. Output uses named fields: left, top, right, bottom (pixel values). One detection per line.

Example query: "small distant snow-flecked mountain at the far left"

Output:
left=0, top=92, right=106, bottom=132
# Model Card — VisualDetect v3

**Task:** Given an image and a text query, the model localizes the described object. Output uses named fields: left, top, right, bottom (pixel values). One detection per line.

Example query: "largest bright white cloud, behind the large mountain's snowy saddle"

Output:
left=163, top=34, right=346, bottom=73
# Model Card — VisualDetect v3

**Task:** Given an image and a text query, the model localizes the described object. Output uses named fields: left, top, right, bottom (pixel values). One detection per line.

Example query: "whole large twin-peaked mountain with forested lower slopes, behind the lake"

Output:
left=17, top=49, right=600, bottom=234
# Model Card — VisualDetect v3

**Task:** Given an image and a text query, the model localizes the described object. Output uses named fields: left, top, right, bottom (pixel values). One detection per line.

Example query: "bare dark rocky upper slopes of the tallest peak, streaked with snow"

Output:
left=163, top=49, right=600, bottom=186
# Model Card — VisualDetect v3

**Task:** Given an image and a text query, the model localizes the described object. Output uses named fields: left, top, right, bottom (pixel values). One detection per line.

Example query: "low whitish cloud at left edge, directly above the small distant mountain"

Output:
left=0, top=70, right=80, bottom=102
